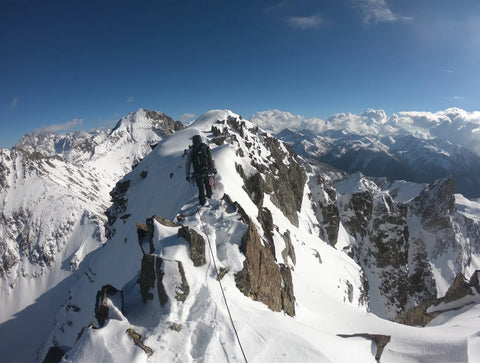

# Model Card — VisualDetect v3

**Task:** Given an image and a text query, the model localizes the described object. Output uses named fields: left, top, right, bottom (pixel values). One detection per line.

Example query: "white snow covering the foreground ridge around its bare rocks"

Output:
left=32, top=111, right=480, bottom=362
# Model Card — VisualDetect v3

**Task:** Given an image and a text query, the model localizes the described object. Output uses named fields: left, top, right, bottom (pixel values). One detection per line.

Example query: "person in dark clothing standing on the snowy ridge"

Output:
left=185, top=135, right=217, bottom=205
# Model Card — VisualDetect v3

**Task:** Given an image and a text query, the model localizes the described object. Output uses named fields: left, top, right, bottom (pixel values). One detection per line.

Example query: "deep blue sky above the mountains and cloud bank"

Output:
left=0, top=0, right=480, bottom=147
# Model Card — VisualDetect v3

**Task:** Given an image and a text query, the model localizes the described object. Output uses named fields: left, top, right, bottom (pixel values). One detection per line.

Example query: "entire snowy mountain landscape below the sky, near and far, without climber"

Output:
left=0, top=109, right=480, bottom=362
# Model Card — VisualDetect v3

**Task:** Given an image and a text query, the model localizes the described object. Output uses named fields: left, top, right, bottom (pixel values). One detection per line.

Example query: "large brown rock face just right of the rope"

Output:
left=235, top=219, right=295, bottom=316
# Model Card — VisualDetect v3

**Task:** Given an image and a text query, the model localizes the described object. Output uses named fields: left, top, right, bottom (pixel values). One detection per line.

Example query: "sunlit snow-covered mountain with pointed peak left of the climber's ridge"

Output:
left=0, top=109, right=180, bottom=346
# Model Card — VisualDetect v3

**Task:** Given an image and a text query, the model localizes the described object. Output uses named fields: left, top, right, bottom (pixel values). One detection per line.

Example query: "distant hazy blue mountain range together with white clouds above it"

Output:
left=272, top=109, right=480, bottom=198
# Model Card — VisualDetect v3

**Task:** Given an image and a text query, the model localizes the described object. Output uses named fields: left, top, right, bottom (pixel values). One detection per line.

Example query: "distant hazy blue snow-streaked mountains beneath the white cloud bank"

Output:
left=277, top=129, right=480, bottom=198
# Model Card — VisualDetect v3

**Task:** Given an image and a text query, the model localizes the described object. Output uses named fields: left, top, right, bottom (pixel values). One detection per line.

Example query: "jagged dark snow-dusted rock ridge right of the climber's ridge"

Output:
left=310, top=175, right=480, bottom=319
